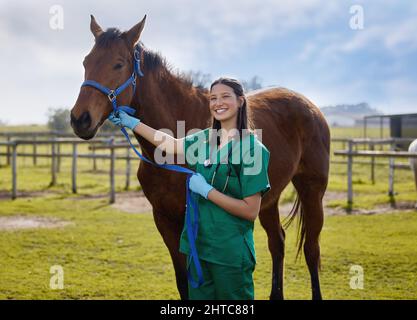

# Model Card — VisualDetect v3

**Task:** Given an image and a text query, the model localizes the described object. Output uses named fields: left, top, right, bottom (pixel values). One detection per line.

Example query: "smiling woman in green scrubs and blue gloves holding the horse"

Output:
left=109, top=78, right=270, bottom=300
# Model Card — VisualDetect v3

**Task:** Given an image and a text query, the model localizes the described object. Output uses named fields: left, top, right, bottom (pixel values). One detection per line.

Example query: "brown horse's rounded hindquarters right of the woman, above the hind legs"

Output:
left=247, top=87, right=330, bottom=198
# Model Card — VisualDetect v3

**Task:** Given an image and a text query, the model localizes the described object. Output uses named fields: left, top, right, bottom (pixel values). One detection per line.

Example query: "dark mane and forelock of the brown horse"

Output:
left=96, top=28, right=203, bottom=89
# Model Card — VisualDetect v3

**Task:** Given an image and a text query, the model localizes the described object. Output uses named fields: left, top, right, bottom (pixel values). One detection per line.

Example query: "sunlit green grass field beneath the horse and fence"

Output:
left=0, top=128, right=417, bottom=299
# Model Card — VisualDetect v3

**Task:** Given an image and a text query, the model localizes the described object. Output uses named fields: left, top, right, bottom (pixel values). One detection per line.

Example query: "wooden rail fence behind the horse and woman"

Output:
left=0, top=132, right=416, bottom=207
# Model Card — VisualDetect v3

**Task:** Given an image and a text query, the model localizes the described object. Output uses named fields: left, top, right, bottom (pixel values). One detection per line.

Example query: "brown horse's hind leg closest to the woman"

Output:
left=259, top=200, right=285, bottom=300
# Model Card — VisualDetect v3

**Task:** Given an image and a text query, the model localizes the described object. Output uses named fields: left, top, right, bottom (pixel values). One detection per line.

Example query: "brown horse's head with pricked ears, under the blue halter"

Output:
left=71, top=16, right=146, bottom=140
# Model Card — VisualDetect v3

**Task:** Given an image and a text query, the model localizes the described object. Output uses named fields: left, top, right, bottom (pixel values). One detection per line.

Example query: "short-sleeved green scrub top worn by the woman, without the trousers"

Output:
left=180, top=128, right=270, bottom=267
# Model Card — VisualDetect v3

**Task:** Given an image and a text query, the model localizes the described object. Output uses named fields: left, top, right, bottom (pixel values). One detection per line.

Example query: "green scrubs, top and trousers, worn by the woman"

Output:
left=180, top=129, right=270, bottom=300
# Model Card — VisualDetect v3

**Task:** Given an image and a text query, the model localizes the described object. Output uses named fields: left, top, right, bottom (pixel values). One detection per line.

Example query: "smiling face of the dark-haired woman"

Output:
left=210, top=83, right=243, bottom=124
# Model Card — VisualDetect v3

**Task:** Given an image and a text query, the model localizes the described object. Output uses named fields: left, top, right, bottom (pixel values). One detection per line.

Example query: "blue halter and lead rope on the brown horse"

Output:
left=81, top=45, right=204, bottom=288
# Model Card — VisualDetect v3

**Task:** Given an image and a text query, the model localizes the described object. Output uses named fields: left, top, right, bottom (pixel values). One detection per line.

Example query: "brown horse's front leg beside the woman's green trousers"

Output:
left=154, top=211, right=188, bottom=300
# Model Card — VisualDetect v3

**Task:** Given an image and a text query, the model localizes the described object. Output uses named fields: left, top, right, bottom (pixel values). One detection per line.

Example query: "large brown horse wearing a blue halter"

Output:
left=71, top=16, right=330, bottom=299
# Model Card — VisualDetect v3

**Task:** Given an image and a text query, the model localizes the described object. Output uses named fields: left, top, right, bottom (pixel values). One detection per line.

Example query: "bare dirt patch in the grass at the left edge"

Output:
left=0, top=216, right=73, bottom=231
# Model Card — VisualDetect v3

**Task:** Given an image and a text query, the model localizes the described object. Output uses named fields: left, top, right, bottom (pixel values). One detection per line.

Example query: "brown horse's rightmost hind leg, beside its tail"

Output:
left=292, top=174, right=327, bottom=300
